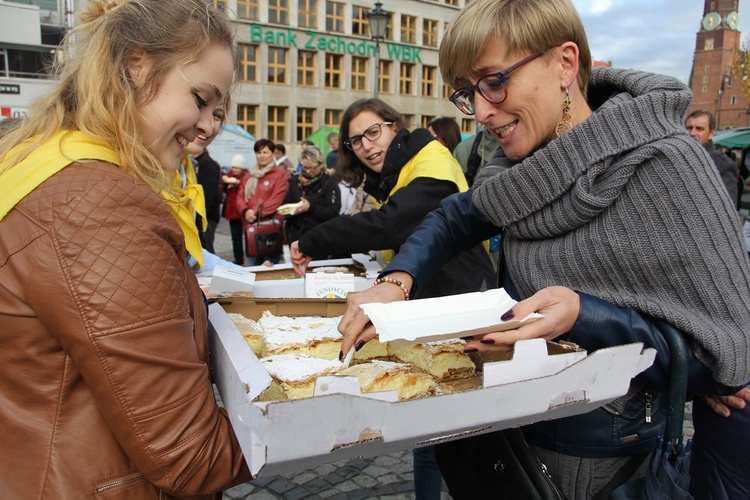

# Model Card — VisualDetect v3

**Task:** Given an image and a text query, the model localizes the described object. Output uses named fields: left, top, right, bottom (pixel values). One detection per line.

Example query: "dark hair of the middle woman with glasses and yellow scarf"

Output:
left=336, top=99, right=406, bottom=186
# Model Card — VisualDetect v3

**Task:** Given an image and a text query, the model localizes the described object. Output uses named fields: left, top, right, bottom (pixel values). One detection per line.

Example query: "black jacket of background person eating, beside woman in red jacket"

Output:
left=284, top=173, right=341, bottom=243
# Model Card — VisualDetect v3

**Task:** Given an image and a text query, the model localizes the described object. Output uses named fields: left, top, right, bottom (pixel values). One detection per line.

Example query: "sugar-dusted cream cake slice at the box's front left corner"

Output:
left=258, top=353, right=342, bottom=401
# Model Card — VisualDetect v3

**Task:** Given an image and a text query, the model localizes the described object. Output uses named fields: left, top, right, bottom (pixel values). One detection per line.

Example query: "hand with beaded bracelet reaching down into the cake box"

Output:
left=339, top=271, right=414, bottom=358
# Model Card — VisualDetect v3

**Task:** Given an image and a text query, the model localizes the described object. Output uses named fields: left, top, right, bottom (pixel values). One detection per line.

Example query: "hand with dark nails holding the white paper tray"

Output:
left=466, top=286, right=581, bottom=352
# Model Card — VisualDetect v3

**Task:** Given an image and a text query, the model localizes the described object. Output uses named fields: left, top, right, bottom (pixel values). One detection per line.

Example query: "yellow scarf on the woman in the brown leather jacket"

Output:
left=0, top=130, right=205, bottom=265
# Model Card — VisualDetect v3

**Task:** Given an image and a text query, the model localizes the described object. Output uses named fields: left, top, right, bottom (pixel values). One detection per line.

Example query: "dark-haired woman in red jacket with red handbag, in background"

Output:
left=248, top=139, right=289, bottom=266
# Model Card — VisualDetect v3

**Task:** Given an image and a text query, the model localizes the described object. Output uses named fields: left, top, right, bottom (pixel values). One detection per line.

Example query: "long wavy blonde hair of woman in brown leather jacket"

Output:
left=0, top=0, right=239, bottom=190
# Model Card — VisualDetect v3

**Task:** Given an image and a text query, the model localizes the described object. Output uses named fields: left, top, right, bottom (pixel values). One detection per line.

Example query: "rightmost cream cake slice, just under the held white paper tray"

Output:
left=388, top=339, right=476, bottom=382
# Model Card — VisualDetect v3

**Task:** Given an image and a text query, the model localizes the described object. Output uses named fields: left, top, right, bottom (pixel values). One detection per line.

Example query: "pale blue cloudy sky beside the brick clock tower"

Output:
left=572, top=0, right=750, bottom=83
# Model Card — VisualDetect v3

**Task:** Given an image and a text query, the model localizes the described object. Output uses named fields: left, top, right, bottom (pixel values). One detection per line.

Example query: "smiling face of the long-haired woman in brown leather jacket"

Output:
left=128, top=43, right=234, bottom=171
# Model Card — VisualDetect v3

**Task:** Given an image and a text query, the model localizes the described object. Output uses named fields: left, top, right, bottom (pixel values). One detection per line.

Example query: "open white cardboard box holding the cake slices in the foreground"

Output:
left=209, top=298, right=655, bottom=477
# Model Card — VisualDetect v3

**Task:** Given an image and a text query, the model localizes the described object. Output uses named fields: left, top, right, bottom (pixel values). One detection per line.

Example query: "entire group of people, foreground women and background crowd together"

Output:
left=0, top=0, right=750, bottom=500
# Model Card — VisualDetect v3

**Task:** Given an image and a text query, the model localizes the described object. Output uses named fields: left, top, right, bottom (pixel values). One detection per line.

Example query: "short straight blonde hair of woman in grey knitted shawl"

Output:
left=439, top=0, right=592, bottom=96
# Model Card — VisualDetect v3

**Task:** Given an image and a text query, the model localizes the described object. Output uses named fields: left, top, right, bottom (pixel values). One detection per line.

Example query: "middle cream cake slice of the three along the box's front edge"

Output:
left=339, top=360, right=437, bottom=401
